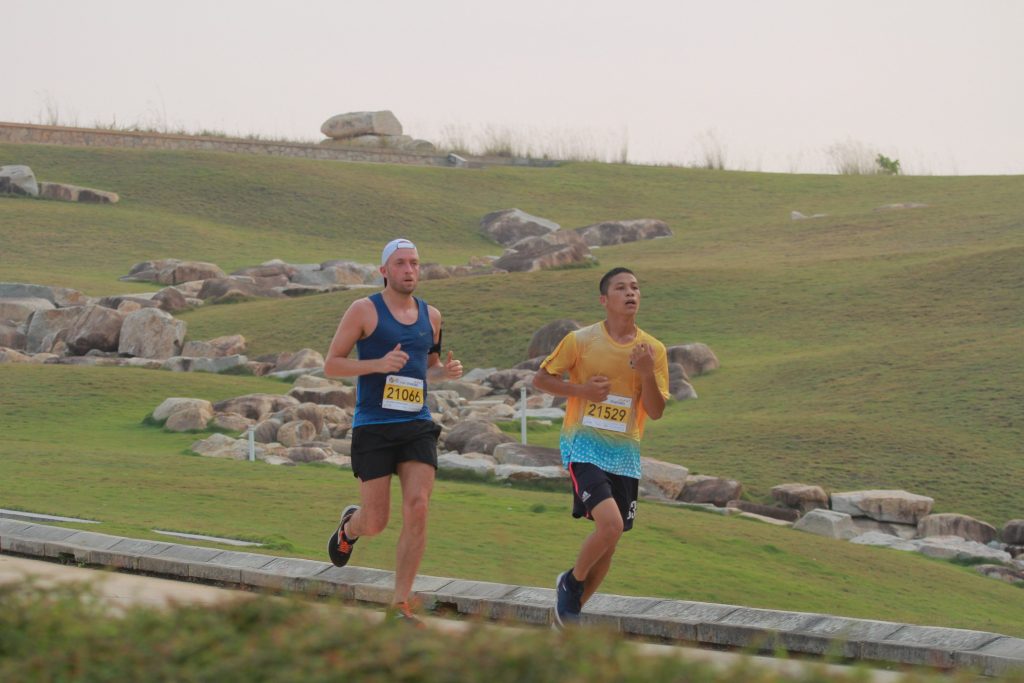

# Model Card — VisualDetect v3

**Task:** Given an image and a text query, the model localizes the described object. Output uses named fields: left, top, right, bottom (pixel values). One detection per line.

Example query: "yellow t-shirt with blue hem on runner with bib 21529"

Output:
left=541, top=322, right=669, bottom=479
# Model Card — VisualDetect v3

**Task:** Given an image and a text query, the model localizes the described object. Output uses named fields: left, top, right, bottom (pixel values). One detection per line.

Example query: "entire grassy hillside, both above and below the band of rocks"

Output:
left=0, top=145, right=1024, bottom=635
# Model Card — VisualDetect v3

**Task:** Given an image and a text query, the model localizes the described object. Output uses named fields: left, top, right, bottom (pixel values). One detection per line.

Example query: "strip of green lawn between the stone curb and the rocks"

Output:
left=0, top=366, right=1024, bottom=635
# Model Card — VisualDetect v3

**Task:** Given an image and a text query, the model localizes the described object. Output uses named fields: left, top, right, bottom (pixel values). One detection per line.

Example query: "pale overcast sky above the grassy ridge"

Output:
left=0, top=0, right=1024, bottom=174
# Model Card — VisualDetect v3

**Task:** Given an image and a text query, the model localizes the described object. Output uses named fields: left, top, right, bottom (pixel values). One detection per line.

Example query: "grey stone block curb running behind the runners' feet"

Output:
left=0, top=518, right=1024, bottom=676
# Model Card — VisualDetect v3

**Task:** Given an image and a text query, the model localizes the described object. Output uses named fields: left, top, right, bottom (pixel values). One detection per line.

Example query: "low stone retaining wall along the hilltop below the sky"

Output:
left=0, top=122, right=555, bottom=167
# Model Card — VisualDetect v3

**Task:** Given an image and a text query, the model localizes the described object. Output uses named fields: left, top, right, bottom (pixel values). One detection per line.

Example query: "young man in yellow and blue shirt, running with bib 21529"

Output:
left=534, top=267, right=669, bottom=628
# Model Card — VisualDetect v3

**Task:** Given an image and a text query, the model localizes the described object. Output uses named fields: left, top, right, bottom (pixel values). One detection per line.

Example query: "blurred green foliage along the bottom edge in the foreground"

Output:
left=0, top=584, right=1024, bottom=683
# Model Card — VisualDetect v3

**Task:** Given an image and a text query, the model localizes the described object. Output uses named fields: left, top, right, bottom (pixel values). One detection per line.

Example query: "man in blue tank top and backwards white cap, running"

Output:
left=324, top=240, right=462, bottom=624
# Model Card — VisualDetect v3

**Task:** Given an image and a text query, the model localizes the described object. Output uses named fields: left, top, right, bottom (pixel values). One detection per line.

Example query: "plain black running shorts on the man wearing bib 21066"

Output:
left=352, top=420, right=441, bottom=481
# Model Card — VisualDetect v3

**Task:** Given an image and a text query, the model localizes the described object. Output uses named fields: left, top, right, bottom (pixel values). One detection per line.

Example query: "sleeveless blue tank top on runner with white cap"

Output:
left=352, top=292, right=434, bottom=427
